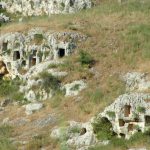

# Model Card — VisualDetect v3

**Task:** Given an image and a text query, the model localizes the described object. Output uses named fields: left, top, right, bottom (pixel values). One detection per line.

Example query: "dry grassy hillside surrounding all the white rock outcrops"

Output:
left=0, top=0, right=150, bottom=150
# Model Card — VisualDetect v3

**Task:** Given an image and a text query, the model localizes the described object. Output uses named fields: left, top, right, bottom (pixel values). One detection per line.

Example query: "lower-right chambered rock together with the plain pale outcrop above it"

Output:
left=92, top=72, right=150, bottom=139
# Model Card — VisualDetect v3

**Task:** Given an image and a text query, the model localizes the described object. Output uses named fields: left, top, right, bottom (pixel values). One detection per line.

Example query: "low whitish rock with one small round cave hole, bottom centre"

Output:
left=51, top=121, right=97, bottom=149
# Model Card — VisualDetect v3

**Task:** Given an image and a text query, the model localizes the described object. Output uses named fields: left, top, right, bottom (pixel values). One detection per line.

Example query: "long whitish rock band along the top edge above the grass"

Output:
left=1, top=0, right=92, bottom=16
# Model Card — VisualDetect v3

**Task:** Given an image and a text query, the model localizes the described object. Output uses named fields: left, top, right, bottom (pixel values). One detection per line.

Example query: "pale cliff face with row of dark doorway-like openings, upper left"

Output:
left=0, top=28, right=86, bottom=78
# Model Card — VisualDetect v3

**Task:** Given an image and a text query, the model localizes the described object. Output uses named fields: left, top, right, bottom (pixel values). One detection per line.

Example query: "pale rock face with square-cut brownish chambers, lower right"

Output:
left=100, top=93, right=150, bottom=139
